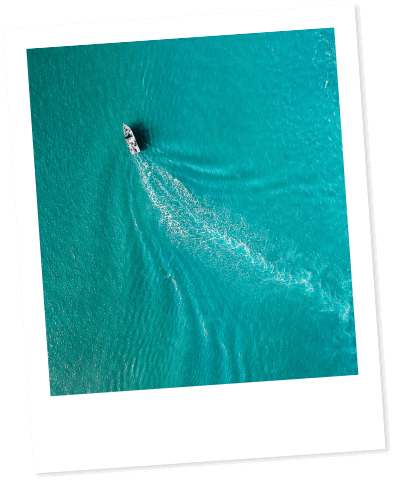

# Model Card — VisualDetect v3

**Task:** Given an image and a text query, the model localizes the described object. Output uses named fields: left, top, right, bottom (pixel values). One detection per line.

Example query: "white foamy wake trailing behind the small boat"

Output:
left=133, top=151, right=353, bottom=321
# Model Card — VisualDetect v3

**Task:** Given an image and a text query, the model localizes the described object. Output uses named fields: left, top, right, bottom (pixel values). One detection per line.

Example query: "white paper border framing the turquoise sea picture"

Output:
left=4, top=5, right=385, bottom=473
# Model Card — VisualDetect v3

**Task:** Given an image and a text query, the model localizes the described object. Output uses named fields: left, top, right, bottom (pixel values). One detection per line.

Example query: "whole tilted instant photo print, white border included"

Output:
left=3, top=5, right=386, bottom=474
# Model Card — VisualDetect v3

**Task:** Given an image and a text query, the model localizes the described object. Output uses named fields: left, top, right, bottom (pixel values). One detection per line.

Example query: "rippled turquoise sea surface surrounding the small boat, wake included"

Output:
left=27, top=29, right=358, bottom=395
